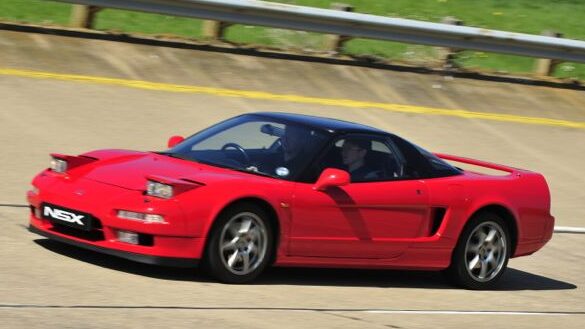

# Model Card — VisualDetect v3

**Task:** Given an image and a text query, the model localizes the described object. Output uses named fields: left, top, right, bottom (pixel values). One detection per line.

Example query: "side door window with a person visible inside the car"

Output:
left=319, top=134, right=402, bottom=183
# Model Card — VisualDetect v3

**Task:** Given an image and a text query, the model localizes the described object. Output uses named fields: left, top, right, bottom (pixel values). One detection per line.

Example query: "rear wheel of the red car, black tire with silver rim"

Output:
left=445, top=212, right=512, bottom=290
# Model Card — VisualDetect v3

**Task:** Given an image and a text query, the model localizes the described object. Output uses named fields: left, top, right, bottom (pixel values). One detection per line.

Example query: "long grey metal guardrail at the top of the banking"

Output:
left=58, top=0, right=585, bottom=73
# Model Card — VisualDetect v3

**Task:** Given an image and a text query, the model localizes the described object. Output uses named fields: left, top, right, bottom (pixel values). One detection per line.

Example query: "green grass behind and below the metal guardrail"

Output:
left=0, top=0, right=585, bottom=80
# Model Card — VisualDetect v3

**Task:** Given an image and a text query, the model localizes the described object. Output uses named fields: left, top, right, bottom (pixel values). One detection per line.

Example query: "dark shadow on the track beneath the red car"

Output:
left=34, top=239, right=577, bottom=291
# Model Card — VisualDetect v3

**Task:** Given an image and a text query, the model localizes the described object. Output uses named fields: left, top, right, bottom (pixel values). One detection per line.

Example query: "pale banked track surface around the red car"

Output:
left=0, top=26, right=585, bottom=328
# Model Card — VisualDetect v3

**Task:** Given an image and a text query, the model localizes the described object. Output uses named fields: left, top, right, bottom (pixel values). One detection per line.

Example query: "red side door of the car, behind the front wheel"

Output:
left=289, top=136, right=430, bottom=258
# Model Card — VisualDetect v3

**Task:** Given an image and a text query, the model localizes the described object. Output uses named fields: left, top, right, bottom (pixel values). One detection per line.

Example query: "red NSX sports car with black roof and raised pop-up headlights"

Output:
left=27, top=113, right=554, bottom=289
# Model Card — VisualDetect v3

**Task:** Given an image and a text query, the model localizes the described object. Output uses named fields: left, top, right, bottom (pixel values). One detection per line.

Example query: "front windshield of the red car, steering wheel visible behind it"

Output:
left=162, top=115, right=328, bottom=180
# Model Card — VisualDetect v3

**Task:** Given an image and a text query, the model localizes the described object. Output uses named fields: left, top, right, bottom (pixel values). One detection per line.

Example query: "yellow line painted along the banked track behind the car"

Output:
left=0, top=68, right=585, bottom=129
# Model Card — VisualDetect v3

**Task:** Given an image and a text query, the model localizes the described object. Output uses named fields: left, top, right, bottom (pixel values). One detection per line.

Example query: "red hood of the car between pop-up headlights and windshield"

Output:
left=76, top=152, right=246, bottom=190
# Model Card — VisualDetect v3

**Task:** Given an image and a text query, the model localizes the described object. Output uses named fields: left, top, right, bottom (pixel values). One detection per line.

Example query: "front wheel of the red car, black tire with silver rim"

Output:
left=204, top=203, right=274, bottom=283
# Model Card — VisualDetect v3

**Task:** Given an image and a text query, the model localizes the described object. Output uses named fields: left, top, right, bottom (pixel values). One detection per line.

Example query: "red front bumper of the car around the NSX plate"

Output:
left=27, top=174, right=205, bottom=267
